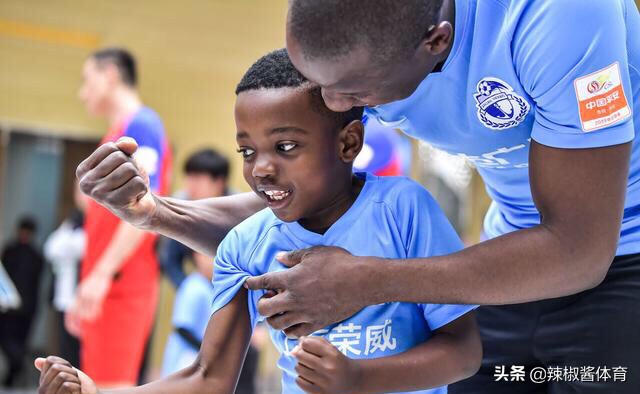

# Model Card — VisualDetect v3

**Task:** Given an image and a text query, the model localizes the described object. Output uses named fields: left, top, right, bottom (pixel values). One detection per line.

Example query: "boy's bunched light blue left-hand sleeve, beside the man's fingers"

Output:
left=211, top=230, right=265, bottom=327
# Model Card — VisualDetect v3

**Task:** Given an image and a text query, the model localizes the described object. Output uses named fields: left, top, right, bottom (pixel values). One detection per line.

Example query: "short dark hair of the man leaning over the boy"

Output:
left=288, top=0, right=443, bottom=63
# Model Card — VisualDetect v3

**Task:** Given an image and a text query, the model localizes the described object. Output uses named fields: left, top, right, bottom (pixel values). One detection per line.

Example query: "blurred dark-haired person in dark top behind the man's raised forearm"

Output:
left=160, top=148, right=229, bottom=289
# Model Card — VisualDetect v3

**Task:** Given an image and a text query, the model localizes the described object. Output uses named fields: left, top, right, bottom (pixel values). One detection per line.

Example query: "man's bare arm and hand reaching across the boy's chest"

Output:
left=246, top=141, right=631, bottom=335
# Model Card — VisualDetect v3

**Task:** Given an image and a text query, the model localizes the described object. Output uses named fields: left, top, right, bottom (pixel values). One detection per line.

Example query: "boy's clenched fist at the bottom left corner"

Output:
left=34, top=356, right=98, bottom=394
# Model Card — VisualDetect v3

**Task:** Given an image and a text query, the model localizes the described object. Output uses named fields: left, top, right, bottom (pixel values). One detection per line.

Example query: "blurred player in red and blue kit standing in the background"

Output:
left=66, top=48, right=171, bottom=388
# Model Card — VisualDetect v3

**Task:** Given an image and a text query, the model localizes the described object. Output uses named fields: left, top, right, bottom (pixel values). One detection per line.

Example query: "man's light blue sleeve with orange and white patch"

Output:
left=512, top=0, right=636, bottom=148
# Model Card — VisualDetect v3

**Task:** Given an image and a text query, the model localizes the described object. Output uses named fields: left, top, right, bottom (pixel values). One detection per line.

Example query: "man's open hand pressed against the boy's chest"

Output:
left=245, top=246, right=376, bottom=338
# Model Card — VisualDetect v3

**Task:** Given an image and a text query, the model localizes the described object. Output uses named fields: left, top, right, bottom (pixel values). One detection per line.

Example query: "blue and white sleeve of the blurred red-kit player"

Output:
left=124, top=115, right=164, bottom=193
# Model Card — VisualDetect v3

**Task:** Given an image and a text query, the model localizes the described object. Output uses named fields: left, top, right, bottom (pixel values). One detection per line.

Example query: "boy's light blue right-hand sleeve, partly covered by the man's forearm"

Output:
left=396, top=181, right=477, bottom=331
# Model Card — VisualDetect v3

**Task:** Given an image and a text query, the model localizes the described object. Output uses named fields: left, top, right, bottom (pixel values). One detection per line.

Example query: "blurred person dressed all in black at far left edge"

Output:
left=0, top=216, right=44, bottom=387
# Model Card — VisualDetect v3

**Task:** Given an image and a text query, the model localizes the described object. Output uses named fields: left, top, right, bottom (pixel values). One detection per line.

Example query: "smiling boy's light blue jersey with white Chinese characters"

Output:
left=213, top=174, right=474, bottom=394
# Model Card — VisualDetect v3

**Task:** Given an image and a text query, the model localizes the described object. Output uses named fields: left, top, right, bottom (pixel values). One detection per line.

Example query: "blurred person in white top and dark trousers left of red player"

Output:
left=44, top=181, right=88, bottom=365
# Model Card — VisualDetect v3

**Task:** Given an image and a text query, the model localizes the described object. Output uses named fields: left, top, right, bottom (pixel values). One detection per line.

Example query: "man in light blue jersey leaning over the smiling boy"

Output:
left=79, top=0, right=640, bottom=393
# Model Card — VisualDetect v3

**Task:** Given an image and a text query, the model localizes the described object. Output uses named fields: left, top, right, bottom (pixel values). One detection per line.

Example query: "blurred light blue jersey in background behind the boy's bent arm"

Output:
left=162, top=272, right=213, bottom=376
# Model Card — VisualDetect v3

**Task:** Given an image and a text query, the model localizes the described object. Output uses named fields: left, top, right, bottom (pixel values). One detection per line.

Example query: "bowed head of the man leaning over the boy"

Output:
left=287, top=0, right=453, bottom=111
